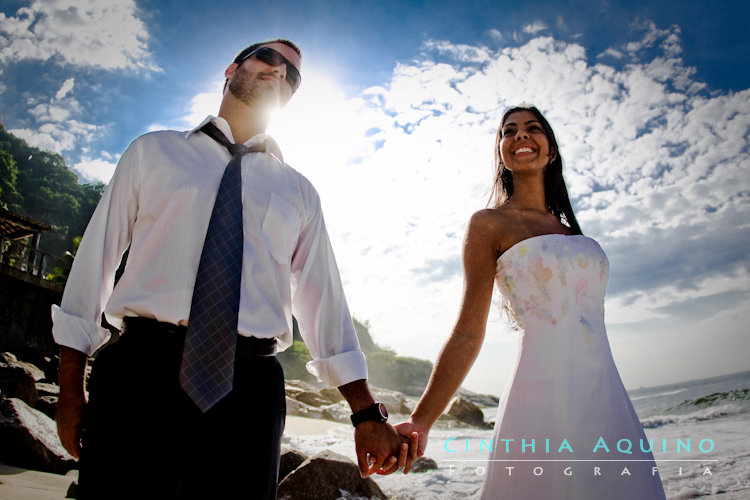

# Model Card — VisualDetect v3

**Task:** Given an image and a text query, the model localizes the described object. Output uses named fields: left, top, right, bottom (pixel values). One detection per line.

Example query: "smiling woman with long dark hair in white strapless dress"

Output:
left=397, top=107, right=664, bottom=500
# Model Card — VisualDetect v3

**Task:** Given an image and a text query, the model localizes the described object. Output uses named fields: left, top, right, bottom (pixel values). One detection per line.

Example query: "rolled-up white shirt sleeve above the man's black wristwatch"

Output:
left=291, top=186, right=367, bottom=387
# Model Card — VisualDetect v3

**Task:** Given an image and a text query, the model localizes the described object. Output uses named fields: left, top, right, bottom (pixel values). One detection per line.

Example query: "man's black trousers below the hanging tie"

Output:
left=79, top=322, right=286, bottom=500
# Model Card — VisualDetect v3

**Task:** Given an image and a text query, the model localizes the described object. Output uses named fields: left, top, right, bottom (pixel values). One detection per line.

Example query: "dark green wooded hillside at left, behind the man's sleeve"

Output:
left=0, top=125, right=106, bottom=257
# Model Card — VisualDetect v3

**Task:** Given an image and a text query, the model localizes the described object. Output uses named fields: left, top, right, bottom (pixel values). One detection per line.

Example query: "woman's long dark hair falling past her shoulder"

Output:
left=488, top=106, right=583, bottom=234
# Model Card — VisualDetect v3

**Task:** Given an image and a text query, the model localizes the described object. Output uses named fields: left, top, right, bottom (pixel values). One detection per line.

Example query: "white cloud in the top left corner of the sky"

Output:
left=0, top=0, right=160, bottom=71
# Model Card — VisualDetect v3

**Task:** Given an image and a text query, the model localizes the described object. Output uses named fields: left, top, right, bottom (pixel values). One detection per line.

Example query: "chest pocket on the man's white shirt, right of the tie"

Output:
left=262, top=193, right=300, bottom=266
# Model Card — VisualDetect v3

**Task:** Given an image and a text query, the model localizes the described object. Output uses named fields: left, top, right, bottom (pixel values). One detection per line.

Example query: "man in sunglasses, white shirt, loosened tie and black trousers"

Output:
left=52, top=39, right=416, bottom=498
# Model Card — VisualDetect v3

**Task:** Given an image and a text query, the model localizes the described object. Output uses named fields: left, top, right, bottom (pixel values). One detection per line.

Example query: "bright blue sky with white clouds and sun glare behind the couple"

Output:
left=0, top=0, right=750, bottom=394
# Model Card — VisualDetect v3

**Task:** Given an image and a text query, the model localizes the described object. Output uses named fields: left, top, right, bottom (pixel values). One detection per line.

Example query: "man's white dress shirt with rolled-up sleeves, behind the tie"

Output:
left=52, top=116, right=367, bottom=386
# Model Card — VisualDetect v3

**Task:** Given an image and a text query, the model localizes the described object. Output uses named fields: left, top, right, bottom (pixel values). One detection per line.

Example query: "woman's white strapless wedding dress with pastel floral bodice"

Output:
left=481, top=234, right=664, bottom=500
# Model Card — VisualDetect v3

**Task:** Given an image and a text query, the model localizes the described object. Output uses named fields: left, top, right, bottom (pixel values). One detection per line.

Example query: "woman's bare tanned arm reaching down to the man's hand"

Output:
left=396, top=210, right=506, bottom=455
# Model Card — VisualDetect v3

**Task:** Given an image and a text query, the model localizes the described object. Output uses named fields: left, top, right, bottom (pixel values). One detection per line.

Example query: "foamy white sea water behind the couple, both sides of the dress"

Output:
left=285, top=371, right=750, bottom=500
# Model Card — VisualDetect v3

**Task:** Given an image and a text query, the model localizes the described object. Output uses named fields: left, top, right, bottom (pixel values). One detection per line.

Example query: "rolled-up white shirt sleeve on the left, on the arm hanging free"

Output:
left=52, top=139, right=139, bottom=356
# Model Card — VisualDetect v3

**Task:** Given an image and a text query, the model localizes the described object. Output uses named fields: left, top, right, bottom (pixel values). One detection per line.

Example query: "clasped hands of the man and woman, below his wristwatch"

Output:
left=354, top=421, right=418, bottom=478
